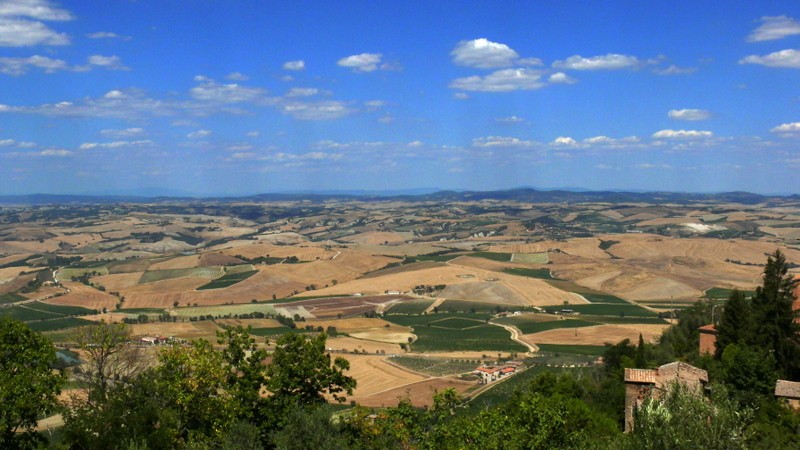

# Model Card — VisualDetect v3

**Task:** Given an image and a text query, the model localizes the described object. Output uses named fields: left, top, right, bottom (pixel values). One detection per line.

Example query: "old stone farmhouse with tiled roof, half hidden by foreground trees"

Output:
left=625, top=361, right=708, bottom=433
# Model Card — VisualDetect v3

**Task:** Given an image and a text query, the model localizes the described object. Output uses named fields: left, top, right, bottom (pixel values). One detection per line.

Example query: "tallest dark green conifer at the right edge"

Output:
left=753, top=250, right=800, bottom=379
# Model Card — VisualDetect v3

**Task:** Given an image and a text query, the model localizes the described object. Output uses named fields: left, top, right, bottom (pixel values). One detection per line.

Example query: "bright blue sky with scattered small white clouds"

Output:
left=0, top=0, right=800, bottom=195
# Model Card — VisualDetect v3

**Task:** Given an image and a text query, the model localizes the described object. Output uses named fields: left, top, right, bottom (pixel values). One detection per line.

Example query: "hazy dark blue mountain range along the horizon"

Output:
left=0, top=188, right=800, bottom=205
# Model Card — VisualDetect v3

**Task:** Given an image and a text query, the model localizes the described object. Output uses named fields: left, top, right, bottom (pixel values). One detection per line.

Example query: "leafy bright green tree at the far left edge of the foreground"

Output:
left=0, top=317, right=64, bottom=449
